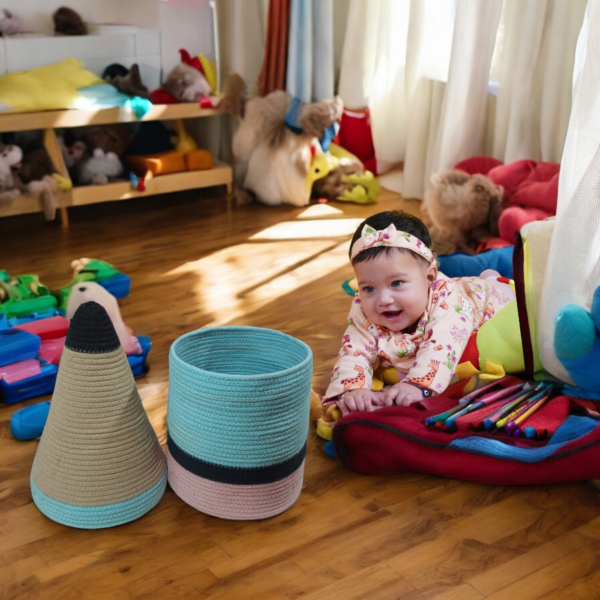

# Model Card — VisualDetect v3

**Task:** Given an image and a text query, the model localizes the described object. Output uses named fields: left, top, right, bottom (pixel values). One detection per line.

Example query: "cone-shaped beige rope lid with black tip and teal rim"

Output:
left=31, top=302, right=167, bottom=529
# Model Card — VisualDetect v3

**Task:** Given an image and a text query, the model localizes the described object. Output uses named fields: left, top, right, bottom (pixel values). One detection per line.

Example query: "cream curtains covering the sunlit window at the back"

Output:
left=339, top=0, right=585, bottom=198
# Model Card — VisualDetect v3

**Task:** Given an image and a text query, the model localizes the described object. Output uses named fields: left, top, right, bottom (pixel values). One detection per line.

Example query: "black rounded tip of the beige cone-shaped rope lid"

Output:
left=65, top=302, right=120, bottom=354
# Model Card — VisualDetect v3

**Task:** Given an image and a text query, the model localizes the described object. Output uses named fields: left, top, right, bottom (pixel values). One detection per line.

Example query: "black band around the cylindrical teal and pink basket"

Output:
left=167, top=434, right=306, bottom=485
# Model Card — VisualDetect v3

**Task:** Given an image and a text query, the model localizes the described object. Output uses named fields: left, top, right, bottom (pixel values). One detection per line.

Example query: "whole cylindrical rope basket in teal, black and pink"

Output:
left=167, top=327, right=312, bottom=520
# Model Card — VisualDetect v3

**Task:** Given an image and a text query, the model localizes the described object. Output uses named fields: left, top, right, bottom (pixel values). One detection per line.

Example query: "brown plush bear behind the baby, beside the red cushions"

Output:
left=421, top=170, right=504, bottom=254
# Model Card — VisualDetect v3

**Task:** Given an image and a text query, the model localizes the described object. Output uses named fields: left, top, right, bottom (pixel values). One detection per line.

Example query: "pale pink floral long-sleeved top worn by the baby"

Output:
left=323, top=273, right=514, bottom=404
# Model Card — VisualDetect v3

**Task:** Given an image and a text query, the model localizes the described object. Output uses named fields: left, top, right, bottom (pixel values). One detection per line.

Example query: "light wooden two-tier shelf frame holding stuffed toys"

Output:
left=0, top=103, right=233, bottom=227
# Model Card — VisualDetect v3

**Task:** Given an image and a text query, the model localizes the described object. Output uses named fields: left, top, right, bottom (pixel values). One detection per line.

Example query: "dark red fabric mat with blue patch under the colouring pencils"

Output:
left=333, top=378, right=600, bottom=485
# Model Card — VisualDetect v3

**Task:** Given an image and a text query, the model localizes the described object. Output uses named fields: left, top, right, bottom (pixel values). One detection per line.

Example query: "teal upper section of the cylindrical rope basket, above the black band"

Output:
left=167, top=327, right=313, bottom=469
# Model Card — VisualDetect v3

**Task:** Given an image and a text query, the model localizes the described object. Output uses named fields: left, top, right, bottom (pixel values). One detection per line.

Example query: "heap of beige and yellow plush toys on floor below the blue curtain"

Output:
left=222, top=75, right=379, bottom=206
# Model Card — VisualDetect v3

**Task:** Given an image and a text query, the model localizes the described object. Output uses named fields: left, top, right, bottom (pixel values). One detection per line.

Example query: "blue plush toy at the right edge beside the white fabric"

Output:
left=554, top=287, right=600, bottom=399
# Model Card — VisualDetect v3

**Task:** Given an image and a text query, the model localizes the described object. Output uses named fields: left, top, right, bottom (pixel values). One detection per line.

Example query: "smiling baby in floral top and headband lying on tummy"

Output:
left=323, top=211, right=514, bottom=414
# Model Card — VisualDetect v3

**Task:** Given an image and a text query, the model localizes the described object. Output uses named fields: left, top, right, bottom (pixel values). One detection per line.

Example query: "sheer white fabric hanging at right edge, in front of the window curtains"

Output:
left=538, top=0, right=600, bottom=381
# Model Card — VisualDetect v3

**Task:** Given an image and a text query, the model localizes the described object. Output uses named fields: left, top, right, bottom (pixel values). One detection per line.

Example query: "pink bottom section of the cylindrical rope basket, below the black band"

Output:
left=167, top=449, right=304, bottom=521
